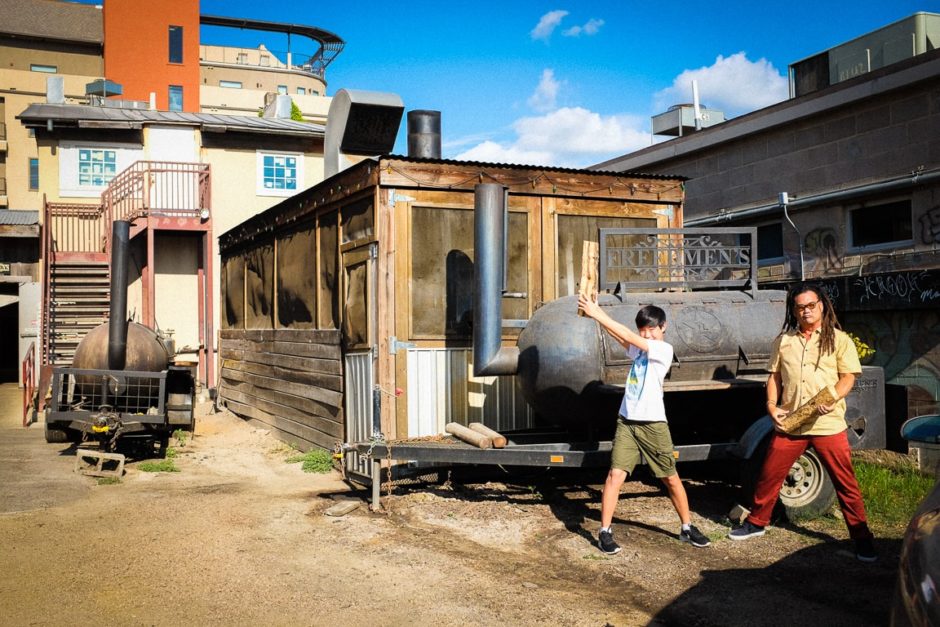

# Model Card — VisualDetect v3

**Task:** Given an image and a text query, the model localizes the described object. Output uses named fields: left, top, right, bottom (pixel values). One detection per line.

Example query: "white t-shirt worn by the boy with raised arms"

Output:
left=620, top=340, right=672, bottom=422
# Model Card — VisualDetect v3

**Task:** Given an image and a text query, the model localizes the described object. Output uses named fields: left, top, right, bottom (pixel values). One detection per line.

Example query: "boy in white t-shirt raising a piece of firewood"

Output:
left=578, top=294, right=711, bottom=555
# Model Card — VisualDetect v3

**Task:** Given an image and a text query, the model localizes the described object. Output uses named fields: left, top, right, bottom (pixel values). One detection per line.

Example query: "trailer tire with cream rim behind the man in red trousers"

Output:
left=740, top=437, right=836, bottom=522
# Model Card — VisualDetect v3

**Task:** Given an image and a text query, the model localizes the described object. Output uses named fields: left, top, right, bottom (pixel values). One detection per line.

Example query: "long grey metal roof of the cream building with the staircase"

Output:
left=17, top=104, right=325, bottom=137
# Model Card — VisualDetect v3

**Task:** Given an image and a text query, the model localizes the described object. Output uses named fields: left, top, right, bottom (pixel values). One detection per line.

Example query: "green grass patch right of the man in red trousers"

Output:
left=853, top=459, right=934, bottom=532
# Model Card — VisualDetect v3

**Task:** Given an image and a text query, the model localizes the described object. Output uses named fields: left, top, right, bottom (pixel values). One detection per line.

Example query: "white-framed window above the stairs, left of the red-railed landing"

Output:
left=59, top=142, right=144, bottom=197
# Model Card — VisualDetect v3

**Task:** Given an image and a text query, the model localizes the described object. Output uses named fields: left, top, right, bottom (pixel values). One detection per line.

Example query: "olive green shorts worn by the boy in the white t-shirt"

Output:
left=610, top=418, right=676, bottom=479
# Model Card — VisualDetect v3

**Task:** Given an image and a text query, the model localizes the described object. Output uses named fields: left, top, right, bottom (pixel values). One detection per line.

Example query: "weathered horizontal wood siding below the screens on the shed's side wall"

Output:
left=219, top=329, right=344, bottom=450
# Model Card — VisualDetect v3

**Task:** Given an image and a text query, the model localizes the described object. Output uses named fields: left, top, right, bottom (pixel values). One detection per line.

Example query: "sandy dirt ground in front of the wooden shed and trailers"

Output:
left=0, top=394, right=899, bottom=627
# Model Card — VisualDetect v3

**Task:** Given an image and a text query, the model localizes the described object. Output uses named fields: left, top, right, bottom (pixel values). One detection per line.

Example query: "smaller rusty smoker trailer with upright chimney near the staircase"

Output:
left=46, top=220, right=195, bottom=455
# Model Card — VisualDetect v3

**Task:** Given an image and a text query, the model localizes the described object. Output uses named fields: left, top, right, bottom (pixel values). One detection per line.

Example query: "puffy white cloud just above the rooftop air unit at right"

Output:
left=655, top=52, right=789, bottom=117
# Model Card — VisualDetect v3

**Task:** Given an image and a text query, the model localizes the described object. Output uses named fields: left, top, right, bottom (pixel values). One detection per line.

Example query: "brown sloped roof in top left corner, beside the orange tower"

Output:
left=0, top=0, right=104, bottom=44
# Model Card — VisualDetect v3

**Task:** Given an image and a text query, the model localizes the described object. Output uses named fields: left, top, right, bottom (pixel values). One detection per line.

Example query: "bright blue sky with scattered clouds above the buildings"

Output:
left=201, top=0, right=940, bottom=167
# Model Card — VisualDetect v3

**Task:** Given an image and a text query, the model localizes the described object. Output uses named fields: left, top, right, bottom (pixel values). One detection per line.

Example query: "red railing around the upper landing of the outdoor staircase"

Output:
left=101, top=161, right=210, bottom=224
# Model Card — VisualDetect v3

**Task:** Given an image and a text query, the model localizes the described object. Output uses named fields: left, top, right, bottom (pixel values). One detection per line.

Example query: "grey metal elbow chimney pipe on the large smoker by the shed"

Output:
left=473, top=183, right=519, bottom=377
